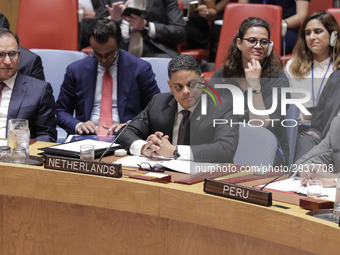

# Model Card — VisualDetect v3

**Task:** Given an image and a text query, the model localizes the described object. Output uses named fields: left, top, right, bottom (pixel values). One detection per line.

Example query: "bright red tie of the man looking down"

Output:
left=98, top=68, right=113, bottom=135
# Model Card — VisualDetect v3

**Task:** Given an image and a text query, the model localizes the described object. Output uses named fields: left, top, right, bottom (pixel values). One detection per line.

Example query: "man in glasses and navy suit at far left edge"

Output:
left=0, top=28, right=57, bottom=142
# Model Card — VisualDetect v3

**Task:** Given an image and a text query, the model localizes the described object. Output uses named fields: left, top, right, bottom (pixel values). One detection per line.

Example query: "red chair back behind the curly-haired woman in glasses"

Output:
left=215, top=3, right=282, bottom=71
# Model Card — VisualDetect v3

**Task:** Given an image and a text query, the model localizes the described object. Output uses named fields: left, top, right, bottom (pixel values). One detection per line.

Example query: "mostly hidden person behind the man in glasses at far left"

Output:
left=0, top=13, right=45, bottom=81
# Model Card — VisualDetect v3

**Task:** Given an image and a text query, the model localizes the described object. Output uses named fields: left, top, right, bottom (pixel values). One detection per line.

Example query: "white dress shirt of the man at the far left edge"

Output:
left=0, top=73, right=17, bottom=138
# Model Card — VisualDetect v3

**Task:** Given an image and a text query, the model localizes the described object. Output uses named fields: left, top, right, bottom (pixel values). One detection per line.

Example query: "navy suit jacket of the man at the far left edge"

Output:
left=6, top=72, right=57, bottom=142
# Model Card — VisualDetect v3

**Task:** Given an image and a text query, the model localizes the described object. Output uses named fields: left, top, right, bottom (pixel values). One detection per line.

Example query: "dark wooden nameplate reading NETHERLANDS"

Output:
left=45, top=155, right=122, bottom=178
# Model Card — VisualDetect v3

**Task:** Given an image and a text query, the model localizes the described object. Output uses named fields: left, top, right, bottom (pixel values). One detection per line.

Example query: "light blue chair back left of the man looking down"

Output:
left=31, top=49, right=87, bottom=143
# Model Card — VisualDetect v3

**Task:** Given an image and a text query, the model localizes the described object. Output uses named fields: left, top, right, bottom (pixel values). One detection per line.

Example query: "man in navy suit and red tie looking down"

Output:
left=57, top=19, right=160, bottom=135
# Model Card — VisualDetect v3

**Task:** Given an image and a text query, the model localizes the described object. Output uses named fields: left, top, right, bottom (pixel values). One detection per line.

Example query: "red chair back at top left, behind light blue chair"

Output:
left=17, top=0, right=79, bottom=50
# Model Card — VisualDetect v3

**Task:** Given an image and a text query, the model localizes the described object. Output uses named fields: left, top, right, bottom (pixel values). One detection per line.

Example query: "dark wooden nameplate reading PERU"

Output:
left=204, top=179, right=272, bottom=206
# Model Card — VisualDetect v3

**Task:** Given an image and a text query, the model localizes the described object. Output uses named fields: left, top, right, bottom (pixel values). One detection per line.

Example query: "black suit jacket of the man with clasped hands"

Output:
left=117, top=93, right=239, bottom=163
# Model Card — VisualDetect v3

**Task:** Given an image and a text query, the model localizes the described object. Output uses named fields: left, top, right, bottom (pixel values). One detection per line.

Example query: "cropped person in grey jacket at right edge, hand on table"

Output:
left=293, top=116, right=340, bottom=187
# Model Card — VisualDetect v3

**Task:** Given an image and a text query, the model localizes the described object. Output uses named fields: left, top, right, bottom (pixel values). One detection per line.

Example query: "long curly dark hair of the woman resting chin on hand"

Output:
left=222, top=17, right=282, bottom=78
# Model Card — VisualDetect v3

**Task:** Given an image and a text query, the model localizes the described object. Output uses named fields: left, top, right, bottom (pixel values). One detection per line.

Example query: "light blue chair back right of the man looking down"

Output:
left=141, top=57, right=171, bottom=93
